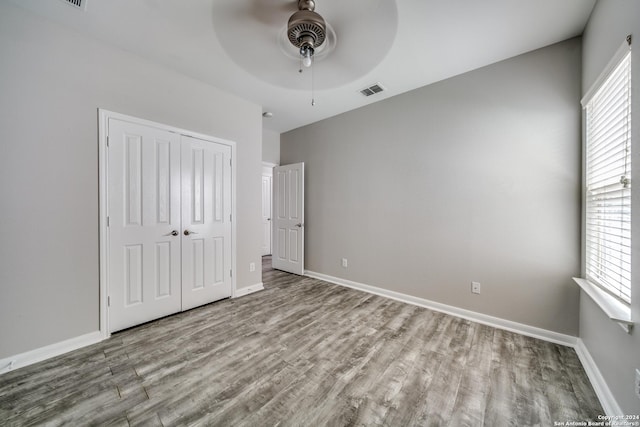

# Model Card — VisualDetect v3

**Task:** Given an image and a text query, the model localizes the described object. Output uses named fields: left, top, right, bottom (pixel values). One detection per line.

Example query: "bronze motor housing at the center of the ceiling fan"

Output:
left=287, top=0, right=327, bottom=53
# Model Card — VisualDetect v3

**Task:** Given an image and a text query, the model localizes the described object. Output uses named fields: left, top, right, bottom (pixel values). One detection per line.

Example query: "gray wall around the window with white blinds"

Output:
left=580, top=0, right=640, bottom=414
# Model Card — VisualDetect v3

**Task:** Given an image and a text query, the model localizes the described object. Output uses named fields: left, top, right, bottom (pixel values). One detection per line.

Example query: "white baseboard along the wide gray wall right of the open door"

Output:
left=305, top=270, right=577, bottom=348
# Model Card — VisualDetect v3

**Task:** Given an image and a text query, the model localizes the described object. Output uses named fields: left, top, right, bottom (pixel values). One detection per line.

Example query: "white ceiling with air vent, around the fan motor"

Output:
left=11, top=0, right=596, bottom=132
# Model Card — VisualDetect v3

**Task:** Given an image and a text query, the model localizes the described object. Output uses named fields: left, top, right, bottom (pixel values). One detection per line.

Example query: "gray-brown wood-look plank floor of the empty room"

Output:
left=0, top=260, right=603, bottom=427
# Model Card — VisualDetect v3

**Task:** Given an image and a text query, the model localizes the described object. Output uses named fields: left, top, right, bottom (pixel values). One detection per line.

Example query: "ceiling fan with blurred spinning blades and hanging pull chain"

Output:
left=212, top=0, right=398, bottom=92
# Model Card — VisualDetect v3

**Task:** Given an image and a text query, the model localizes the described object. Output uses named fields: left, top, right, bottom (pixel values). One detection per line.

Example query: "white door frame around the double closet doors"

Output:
left=98, top=108, right=237, bottom=339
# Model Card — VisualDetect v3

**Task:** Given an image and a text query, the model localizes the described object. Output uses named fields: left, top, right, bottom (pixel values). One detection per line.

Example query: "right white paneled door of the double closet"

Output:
left=181, top=136, right=232, bottom=310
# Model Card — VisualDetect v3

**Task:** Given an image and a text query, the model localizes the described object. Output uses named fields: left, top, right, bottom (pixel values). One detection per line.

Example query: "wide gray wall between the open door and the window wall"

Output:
left=281, top=38, right=581, bottom=335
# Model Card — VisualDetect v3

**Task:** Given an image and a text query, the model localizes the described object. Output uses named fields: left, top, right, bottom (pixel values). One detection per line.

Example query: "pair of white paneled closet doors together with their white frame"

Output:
left=100, top=110, right=235, bottom=337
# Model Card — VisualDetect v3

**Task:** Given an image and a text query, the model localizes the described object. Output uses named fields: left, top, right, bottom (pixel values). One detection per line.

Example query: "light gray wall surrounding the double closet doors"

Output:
left=0, top=2, right=262, bottom=358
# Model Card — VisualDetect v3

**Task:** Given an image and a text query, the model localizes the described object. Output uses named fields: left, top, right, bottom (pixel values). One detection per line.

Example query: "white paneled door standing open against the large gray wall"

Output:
left=272, top=163, right=304, bottom=274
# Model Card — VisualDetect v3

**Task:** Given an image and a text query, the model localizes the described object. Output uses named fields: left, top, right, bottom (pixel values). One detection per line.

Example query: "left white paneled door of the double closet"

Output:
left=108, top=119, right=181, bottom=332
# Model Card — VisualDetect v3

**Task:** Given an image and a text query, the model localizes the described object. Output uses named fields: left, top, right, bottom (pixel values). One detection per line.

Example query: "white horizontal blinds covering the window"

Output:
left=585, top=49, right=631, bottom=303
